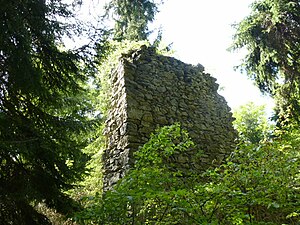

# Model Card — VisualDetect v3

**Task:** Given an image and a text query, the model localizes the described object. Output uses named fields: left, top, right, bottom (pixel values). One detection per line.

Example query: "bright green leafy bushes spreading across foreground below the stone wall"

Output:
left=76, top=124, right=300, bottom=224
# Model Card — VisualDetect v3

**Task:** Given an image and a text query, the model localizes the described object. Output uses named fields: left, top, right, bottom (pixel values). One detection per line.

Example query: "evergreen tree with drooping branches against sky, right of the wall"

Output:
left=233, top=0, right=300, bottom=123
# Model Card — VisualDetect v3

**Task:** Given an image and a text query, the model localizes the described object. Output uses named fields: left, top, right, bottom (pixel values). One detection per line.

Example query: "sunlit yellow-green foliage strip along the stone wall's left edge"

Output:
left=72, top=41, right=147, bottom=199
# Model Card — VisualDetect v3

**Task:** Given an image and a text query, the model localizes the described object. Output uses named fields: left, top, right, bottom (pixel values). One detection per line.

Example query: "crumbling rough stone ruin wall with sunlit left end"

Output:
left=103, top=47, right=236, bottom=190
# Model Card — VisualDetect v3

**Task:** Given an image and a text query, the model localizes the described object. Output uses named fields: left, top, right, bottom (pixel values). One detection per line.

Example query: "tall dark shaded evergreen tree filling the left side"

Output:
left=0, top=0, right=93, bottom=225
